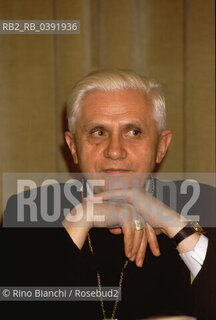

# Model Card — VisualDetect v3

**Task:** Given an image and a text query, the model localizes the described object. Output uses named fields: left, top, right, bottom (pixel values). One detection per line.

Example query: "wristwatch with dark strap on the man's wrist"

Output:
left=170, top=221, right=204, bottom=248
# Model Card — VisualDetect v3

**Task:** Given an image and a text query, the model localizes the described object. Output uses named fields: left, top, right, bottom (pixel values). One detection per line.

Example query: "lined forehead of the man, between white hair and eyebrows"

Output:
left=79, top=90, right=153, bottom=122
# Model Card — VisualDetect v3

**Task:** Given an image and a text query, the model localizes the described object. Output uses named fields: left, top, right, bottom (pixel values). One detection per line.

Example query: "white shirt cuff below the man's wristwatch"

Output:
left=179, top=234, right=208, bottom=277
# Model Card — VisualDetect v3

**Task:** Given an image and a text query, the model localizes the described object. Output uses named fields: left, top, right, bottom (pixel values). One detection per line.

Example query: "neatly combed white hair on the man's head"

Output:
left=67, top=69, right=166, bottom=133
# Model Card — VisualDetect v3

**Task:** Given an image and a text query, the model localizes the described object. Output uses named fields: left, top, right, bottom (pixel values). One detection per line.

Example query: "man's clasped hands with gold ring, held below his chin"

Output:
left=63, top=188, right=179, bottom=267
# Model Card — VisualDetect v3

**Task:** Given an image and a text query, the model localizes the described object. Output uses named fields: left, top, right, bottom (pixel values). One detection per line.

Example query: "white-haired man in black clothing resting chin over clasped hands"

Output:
left=0, top=70, right=215, bottom=319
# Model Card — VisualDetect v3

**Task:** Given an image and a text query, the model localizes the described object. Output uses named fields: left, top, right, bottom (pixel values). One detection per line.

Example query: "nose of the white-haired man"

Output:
left=104, top=134, right=127, bottom=160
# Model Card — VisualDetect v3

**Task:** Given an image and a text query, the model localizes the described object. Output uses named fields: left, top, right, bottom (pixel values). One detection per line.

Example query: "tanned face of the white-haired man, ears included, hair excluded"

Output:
left=65, top=90, right=171, bottom=174
